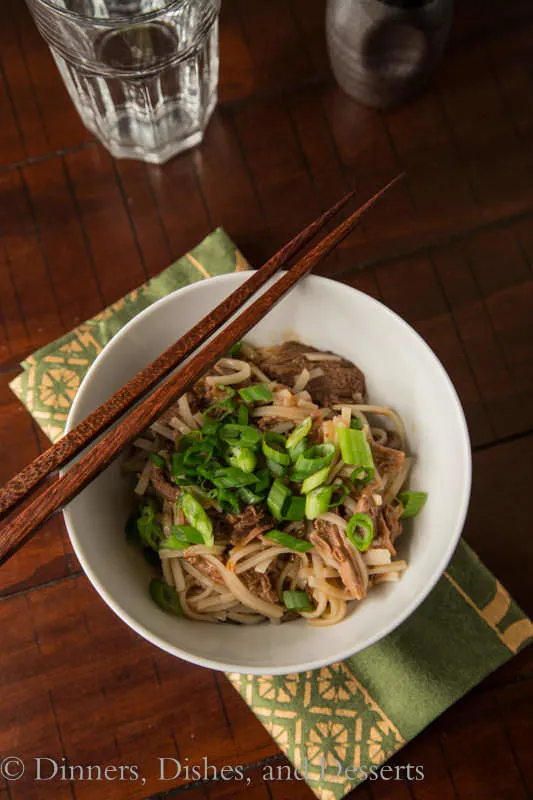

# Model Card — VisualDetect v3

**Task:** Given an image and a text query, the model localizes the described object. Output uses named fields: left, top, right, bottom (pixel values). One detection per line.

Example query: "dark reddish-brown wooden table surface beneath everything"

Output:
left=0, top=0, right=533, bottom=800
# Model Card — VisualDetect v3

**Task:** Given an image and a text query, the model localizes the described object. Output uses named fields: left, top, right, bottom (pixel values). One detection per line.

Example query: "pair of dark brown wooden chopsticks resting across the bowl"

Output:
left=0, top=176, right=402, bottom=564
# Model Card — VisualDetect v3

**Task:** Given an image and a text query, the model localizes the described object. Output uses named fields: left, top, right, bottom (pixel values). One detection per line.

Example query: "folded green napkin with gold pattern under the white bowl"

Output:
left=11, top=230, right=533, bottom=800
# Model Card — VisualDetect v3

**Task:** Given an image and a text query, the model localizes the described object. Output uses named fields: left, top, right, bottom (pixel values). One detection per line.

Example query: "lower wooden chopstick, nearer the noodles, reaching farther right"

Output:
left=0, top=176, right=402, bottom=564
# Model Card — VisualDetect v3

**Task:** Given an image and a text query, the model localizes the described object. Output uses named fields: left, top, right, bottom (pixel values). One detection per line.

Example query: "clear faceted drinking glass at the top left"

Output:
left=26, top=0, right=220, bottom=164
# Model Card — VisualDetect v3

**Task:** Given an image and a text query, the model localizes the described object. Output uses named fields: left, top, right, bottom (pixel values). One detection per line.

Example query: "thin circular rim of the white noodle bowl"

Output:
left=63, top=270, right=472, bottom=675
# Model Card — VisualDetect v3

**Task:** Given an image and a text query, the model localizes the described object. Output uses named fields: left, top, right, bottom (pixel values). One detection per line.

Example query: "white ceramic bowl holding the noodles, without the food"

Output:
left=65, top=273, right=471, bottom=674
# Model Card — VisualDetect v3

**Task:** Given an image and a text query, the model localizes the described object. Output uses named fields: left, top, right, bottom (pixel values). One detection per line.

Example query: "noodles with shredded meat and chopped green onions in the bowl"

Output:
left=124, top=342, right=425, bottom=626
